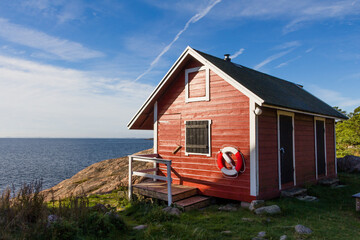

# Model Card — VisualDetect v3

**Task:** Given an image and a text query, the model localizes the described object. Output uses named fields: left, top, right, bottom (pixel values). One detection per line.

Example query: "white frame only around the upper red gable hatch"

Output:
left=185, top=66, right=210, bottom=103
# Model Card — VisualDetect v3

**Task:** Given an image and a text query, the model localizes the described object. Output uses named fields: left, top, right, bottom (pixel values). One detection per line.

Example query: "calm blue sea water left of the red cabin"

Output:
left=0, top=138, right=153, bottom=192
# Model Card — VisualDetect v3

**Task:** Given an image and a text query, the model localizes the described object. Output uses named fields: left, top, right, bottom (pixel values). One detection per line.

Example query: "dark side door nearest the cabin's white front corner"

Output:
left=279, top=115, right=294, bottom=184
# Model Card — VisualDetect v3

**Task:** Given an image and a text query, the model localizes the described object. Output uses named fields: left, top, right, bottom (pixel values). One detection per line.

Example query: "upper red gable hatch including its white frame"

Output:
left=185, top=66, right=210, bottom=102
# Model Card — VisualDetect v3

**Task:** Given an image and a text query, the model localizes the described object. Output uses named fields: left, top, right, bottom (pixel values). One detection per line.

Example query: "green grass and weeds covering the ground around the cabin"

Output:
left=0, top=173, right=360, bottom=240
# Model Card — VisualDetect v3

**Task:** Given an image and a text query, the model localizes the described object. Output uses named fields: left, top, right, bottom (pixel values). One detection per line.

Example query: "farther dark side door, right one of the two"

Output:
left=315, top=120, right=326, bottom=176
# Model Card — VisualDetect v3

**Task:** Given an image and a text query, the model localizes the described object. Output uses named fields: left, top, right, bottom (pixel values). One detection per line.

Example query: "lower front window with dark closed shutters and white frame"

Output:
left=185, top=120, right=211, bottom=156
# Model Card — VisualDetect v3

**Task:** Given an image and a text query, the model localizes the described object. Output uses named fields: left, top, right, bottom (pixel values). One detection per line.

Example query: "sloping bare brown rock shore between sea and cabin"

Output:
left=42, top=149, right=153, bottom=201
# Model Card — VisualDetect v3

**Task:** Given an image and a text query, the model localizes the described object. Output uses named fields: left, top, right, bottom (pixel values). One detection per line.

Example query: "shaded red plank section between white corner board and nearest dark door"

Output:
left=258, top=108, right=279, bottom=199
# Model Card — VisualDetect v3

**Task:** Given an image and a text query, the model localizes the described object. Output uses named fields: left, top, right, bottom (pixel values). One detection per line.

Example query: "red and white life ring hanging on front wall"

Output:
left=217, top=147, right=244, bottom=176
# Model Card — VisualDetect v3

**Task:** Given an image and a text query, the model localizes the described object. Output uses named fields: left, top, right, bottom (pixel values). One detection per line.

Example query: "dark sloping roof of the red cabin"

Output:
left=194, top=49, right=347, bottom=119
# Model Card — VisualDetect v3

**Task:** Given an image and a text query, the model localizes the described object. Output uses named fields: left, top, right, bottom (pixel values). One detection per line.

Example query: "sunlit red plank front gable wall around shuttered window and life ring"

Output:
left=158, top=60, right=254, bottom=201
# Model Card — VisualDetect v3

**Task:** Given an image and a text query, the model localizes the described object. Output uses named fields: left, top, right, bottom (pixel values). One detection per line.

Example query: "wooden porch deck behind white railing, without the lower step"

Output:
left=133, top=182, right=198, bottom=202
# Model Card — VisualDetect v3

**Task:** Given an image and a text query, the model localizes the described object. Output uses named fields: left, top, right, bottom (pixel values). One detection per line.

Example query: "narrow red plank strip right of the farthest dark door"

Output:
left=325, top=119, right=336, bottom=177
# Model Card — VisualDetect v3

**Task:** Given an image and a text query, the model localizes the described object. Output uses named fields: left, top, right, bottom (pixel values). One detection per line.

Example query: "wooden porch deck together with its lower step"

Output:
left=133, top=182, right=210, bottom=211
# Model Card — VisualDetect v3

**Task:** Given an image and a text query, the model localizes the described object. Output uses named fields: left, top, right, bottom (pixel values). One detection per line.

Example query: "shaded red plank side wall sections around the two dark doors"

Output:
left=258, top=108, right=336, bottom=199
